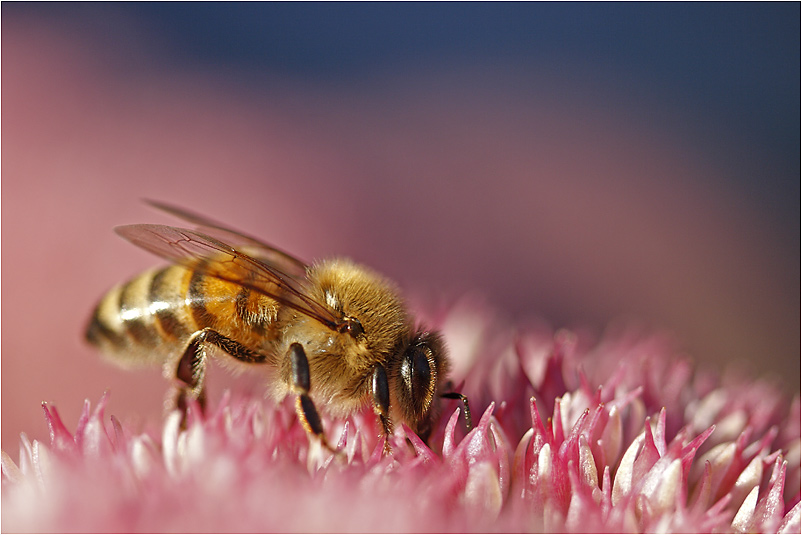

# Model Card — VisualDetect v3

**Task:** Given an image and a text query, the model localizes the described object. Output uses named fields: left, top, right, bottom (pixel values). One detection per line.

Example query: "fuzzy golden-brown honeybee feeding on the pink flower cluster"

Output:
left=86, top=201, right=470, bottom=451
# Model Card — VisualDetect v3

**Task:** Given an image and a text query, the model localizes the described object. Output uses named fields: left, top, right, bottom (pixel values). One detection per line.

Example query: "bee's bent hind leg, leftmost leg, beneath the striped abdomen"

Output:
left=175, top=327, right=267, bottom=418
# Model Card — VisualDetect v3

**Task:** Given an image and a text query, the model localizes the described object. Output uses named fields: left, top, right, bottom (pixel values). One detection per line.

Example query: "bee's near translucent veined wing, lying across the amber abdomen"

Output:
left=114, top=225, right=343, bottom=330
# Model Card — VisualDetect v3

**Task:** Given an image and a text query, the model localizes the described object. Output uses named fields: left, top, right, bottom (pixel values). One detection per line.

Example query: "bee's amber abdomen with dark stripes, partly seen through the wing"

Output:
left=86, top=265, right=278, bottom=365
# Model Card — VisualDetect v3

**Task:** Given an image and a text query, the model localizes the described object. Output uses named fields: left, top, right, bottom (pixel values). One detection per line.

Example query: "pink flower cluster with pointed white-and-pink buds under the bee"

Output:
left=2, top=304, right=802, bottom=532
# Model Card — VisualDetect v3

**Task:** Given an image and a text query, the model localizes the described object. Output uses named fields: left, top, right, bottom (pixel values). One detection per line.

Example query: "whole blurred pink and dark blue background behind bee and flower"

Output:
left=1, top=2, right=800, bottom=459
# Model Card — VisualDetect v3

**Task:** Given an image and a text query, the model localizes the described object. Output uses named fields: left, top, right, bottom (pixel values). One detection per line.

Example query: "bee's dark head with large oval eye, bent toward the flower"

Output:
left=393, top=331, right=448, bottom=441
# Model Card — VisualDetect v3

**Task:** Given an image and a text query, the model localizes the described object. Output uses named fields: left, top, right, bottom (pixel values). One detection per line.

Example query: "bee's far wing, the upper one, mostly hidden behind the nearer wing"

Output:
left=145, top=199, right=306, bottom=279
